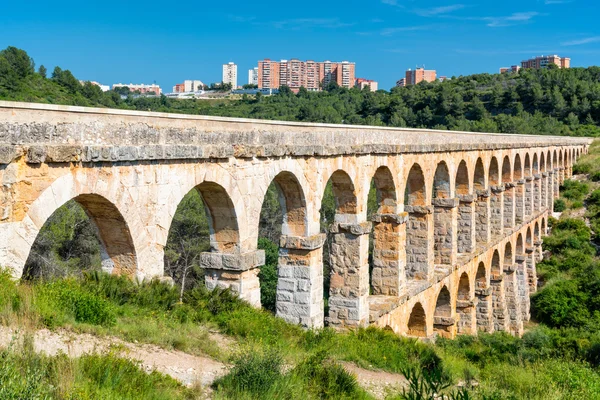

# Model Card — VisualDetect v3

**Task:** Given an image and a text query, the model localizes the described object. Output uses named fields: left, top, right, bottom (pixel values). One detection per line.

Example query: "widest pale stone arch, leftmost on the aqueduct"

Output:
left=13, top=170, right=151, bottom=279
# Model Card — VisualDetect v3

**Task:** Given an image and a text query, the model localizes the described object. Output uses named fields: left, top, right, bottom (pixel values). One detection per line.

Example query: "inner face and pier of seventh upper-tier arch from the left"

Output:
left=432, top=161, right=454, bottom=265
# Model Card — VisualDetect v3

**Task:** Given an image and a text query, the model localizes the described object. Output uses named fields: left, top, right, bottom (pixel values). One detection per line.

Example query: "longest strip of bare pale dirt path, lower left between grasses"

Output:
left=0, top=326, right=227, bottom=386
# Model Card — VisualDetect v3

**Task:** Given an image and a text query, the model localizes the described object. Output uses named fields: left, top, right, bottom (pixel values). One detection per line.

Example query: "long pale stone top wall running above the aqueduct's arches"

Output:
left=0, top=101, right=590, bottom=158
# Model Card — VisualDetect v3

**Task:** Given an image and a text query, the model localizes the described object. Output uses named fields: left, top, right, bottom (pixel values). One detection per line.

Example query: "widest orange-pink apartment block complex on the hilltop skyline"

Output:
left=258, top=59, right=355, bottom=92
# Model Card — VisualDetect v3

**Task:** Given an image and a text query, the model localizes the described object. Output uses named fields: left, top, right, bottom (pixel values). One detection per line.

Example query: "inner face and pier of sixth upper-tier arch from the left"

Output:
left=404, top=164, right=433, bottom=280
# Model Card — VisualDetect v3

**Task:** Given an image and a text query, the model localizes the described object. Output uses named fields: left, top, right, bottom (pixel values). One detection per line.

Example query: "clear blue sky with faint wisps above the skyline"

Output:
left=0, top=0, right=600, bottom=91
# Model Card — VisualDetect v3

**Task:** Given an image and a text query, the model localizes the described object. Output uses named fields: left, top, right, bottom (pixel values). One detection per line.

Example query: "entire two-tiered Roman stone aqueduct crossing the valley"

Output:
left=0, top=102, right=590, bottom=337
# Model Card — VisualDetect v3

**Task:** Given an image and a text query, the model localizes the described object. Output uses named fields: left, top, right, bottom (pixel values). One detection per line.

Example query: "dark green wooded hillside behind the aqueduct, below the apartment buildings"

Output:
left=0, top=47, right=600, bottom=136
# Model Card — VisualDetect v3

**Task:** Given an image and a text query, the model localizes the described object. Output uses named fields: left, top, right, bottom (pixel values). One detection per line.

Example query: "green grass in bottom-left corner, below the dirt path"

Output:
left=0, top=337, right=201, bottom=400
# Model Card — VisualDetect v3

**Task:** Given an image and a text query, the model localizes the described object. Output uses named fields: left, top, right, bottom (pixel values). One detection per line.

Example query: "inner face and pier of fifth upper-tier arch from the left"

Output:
left=370, top=166, right=406, bottom=296
